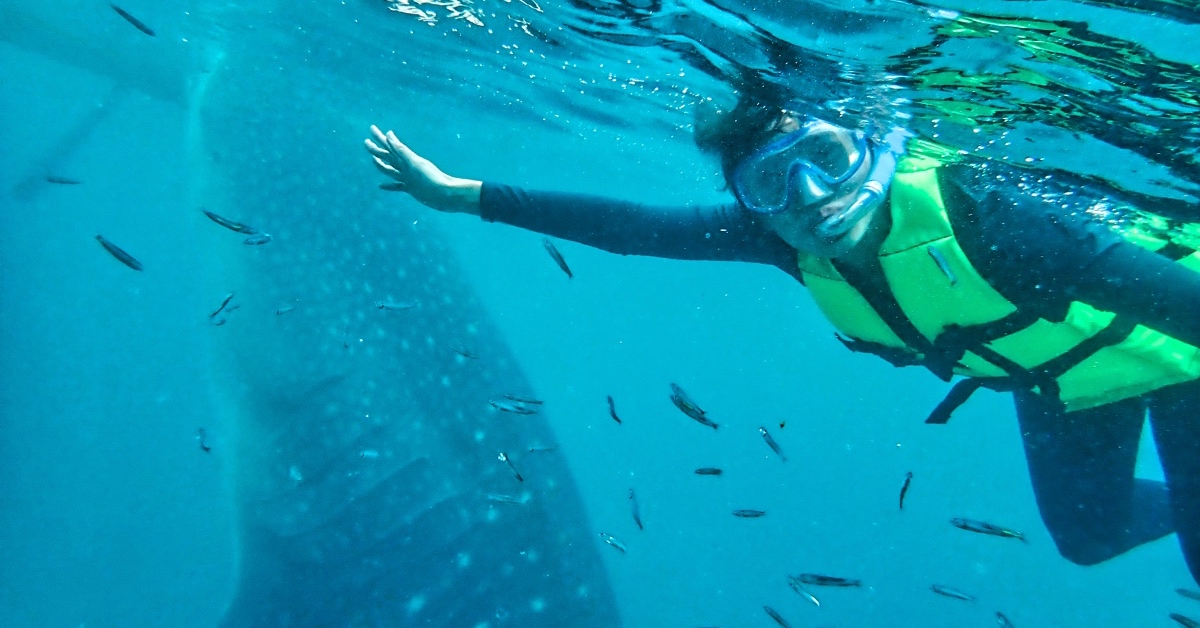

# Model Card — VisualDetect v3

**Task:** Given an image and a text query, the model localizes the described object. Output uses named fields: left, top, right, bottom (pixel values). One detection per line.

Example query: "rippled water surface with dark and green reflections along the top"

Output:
left=217, top=0, right=1200, bottom=238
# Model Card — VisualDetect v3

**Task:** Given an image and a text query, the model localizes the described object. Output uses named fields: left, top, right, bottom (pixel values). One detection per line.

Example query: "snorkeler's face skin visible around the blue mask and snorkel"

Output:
left=763, top=114, right=880, bottom=258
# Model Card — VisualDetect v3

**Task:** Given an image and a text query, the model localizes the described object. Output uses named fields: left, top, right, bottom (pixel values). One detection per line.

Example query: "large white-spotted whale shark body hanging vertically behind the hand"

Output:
left=193, top=31, right=620, bottom=628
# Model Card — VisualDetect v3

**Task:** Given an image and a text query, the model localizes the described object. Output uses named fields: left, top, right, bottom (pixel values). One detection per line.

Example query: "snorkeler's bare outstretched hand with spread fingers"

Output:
left=365, top=125, right=482, bottom=215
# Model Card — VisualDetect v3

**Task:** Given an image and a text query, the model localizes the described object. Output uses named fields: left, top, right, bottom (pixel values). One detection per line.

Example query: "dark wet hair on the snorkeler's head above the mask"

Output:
left=694, top=85, right=787, bottom=187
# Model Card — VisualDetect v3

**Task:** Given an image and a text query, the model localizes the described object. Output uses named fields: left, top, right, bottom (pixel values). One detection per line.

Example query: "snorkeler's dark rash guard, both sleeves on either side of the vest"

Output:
left=480, top=165, right=1200, bottom=346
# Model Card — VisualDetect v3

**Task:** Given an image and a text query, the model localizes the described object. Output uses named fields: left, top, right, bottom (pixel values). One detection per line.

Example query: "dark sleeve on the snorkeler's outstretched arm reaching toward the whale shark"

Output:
left=480, top=183, right=798, bottom=276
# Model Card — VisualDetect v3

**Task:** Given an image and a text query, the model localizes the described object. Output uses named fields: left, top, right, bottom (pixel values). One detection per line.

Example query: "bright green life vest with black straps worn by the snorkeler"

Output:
left=799, top=157, right=1200, bottom=415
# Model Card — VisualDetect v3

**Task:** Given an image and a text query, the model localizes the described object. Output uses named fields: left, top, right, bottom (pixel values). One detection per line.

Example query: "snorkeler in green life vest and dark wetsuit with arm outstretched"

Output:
left=366, top=91, right=1200, bottom=581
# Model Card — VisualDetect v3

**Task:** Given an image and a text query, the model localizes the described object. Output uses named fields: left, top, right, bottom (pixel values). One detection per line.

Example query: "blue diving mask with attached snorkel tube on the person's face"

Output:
left=732, top=111, right=910, bottom=238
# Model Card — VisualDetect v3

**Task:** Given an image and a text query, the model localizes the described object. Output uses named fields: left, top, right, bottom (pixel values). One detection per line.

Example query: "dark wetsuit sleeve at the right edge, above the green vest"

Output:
left=941, top=166, right=1200, bottom=346
